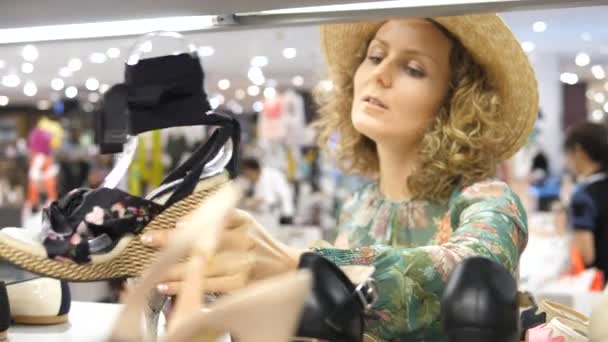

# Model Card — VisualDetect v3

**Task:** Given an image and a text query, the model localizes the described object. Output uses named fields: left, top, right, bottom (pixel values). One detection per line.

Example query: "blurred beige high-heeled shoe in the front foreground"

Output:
left=111, top=186, right=312, bottom=342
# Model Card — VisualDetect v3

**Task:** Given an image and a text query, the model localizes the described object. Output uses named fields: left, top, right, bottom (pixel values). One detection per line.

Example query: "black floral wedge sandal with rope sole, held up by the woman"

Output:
left=0, top=53, right=240, bottom=281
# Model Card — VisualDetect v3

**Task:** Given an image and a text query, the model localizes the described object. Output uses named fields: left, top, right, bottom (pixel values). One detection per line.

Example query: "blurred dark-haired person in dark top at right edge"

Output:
left=565, top=123, right=608, bottom=274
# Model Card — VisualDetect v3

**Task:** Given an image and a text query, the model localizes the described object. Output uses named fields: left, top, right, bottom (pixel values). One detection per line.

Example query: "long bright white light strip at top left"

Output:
left=0, top=15, right=217, bottom=44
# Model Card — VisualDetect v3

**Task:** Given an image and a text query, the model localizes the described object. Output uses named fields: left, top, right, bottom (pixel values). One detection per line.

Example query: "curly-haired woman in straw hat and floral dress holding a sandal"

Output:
left=144, top=14, right=538, bottom=341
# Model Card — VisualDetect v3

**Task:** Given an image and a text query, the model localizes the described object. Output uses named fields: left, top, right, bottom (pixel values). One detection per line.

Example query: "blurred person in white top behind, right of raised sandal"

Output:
left=241, top=158, right=295, bottom=224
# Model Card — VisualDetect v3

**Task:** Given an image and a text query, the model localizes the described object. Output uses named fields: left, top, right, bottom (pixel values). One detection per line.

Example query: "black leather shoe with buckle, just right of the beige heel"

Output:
left=296, top=253, right=377, bottom=342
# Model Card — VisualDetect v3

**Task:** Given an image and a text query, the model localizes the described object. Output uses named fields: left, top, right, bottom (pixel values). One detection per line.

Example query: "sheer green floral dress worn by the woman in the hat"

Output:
left=315, top=180, right=528, bottom=341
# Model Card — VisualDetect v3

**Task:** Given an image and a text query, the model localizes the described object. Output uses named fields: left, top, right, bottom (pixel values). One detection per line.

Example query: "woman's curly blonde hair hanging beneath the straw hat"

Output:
left=315, top=22, right=509, bottom=201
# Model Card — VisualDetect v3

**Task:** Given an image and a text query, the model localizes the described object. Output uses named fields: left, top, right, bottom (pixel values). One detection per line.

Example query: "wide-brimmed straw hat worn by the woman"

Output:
left=321, top=14, right=538, bottom=159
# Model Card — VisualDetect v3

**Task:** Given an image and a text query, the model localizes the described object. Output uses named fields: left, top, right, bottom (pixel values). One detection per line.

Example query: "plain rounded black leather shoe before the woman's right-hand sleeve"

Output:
left=441, top=257, right=519, bottom=342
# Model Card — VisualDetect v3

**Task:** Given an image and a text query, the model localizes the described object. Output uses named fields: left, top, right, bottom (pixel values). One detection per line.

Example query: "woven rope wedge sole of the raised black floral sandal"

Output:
left=0, top=176, right=228, bottom=282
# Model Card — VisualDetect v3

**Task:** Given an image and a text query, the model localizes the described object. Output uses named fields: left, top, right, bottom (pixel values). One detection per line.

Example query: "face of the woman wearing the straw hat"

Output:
left=351, top=19, right=452, bottom=148
